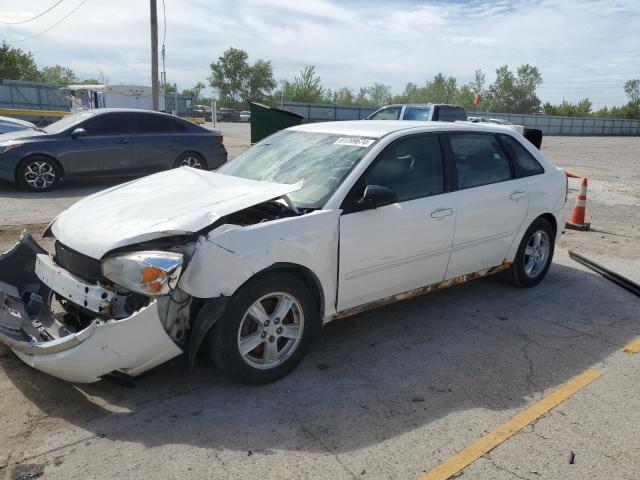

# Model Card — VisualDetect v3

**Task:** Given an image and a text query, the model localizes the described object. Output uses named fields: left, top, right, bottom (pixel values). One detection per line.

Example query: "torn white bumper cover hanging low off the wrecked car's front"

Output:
left=14, top=302, right=182, bottom=383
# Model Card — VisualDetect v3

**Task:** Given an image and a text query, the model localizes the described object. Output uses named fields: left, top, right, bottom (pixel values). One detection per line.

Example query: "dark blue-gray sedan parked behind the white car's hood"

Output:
left=0, top=108, right=227, bottom=191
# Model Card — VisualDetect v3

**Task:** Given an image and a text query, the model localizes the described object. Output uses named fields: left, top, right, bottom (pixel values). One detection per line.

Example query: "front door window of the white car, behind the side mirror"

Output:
left=364, top=135, right=444, bottom=202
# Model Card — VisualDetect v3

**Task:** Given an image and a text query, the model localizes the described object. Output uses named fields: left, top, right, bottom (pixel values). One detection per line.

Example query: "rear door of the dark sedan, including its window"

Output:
left=133, top=112, right=183, bottom=173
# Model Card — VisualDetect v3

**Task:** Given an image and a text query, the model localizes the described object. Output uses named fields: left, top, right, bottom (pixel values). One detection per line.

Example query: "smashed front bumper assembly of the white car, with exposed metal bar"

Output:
left=0, top=232, right=182, bottom=383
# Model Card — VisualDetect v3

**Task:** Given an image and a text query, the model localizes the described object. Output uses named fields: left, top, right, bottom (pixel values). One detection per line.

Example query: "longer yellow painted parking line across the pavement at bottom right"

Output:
left=419, top=369, right=602, bottom=480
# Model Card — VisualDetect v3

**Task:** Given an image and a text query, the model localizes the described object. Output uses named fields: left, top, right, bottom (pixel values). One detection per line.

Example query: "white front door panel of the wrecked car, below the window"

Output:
left=338, top=193, right=455, bottom=310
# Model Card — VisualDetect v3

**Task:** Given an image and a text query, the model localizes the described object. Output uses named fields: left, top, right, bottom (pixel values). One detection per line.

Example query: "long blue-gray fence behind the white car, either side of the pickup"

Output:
left=282, top=102, right=640, bottom=136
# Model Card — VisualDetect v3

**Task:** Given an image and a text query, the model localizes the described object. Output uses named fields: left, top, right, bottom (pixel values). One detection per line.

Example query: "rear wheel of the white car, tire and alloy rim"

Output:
left=506, top=218, right=555, bottom=288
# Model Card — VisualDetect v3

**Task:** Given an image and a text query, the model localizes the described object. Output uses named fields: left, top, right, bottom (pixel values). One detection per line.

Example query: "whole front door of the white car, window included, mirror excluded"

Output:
left=338, top=134, right=456, bottom=311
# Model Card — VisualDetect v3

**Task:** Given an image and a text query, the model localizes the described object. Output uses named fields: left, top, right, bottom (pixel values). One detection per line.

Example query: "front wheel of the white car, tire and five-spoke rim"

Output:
left=209, top=274, right=319, bottom=385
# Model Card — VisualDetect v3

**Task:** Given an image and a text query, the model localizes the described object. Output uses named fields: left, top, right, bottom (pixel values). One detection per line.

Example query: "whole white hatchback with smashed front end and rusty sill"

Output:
left=0, top=121, right=567, bottom=383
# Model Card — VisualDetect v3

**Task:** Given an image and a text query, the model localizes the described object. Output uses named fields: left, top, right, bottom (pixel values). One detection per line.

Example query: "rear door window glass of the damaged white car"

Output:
left=449, top=133, right=512, bottom=188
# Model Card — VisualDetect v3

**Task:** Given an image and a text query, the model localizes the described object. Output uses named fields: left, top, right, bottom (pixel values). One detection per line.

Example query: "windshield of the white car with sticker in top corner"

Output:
left=217, top=130, right=376, bottom=208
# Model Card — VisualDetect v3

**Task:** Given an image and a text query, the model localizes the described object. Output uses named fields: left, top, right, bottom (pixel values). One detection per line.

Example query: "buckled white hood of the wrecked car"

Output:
left=51, top=167, right=302, bottom=259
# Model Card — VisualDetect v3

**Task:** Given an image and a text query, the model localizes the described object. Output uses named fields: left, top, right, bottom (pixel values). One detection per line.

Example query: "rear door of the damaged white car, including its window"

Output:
left=443, top=132, right=528, bottom=279
